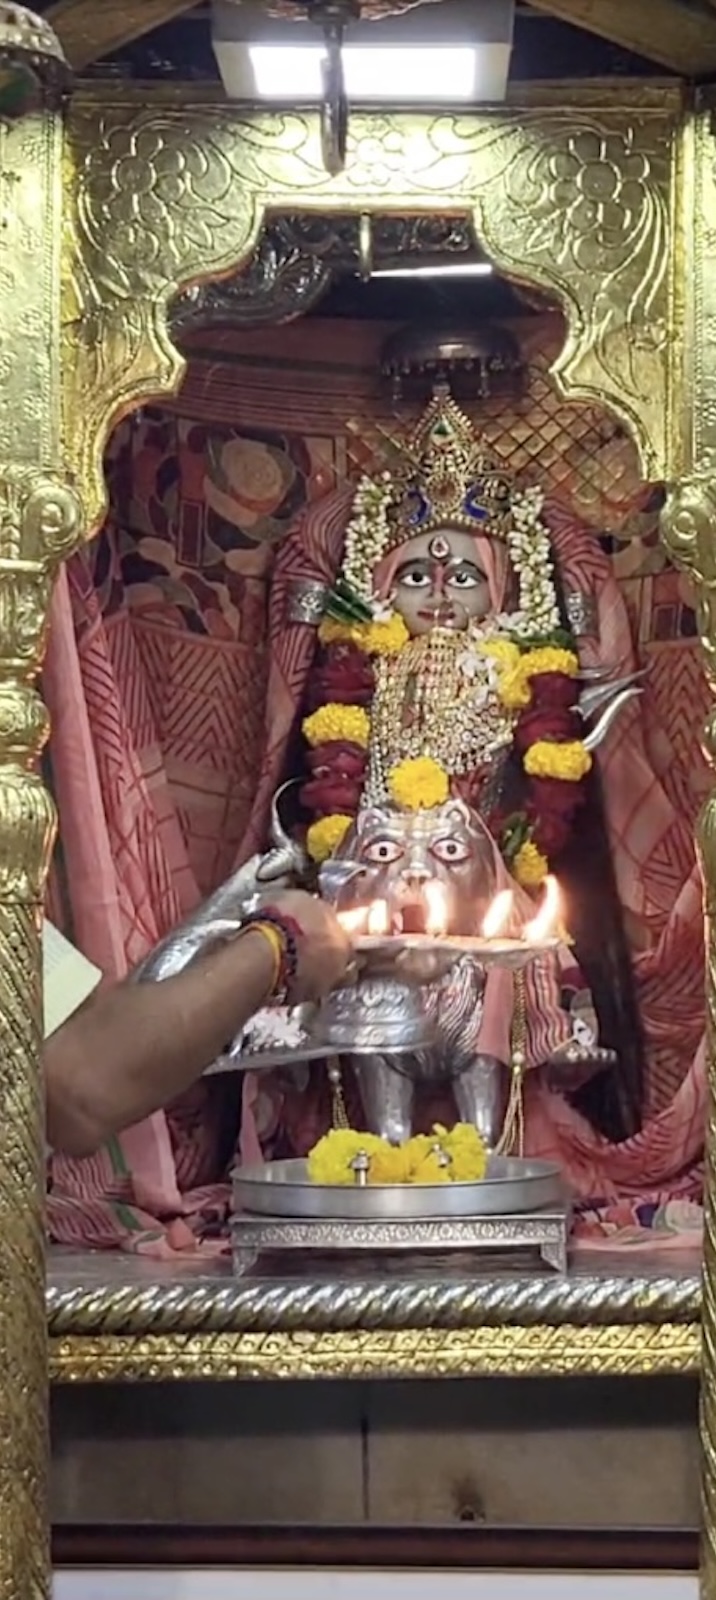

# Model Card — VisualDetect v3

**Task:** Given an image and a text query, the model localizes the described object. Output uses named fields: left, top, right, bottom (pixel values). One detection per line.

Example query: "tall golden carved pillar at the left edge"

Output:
left=0, top=5, right=82, bottom=1600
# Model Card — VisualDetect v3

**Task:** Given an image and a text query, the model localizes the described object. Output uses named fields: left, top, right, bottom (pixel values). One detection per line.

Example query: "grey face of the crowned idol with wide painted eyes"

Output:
left=390, top=528, right=491, bottom=638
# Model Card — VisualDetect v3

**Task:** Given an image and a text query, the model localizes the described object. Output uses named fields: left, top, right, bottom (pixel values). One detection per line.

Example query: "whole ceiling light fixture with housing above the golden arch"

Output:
left=213, top=0, right=515, bottom=171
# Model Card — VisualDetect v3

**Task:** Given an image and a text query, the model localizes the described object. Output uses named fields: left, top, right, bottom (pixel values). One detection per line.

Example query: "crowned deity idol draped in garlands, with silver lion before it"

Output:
left=289, top=394, right=641, bottom=1149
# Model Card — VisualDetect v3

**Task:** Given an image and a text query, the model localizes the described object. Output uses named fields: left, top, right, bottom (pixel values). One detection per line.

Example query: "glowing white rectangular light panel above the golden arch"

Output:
left=248, top=45, right=479, bottom=104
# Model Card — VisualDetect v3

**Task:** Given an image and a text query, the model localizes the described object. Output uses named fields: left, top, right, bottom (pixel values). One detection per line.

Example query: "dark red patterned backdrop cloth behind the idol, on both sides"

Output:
left=119, top=315, right=708, bottom=864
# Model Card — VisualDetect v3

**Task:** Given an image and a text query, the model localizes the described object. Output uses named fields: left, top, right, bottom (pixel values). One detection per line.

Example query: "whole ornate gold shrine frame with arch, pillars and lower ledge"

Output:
left=0, top=83, right=716, bottom=1597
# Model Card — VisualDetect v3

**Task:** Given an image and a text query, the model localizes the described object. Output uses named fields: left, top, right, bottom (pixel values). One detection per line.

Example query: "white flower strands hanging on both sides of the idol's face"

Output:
left=344, top=472, right=559, bottom=638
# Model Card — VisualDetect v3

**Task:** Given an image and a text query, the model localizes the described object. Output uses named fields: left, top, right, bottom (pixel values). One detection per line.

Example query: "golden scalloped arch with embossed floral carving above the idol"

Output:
left=62, top=86, right=682, bottom=525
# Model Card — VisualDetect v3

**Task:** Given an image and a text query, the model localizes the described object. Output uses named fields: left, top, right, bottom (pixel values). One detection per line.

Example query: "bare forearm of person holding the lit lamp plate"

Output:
left=45, top=931, right=275, bottom=1155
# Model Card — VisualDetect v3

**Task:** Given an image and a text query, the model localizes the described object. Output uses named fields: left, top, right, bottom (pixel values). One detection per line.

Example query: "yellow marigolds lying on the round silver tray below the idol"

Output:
left=307, top=1122, right=487, bottom=1186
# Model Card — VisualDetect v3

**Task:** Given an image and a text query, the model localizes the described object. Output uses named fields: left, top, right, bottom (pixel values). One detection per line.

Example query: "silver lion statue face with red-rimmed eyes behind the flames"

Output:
left=332, top=800, right=495, bottom=934
